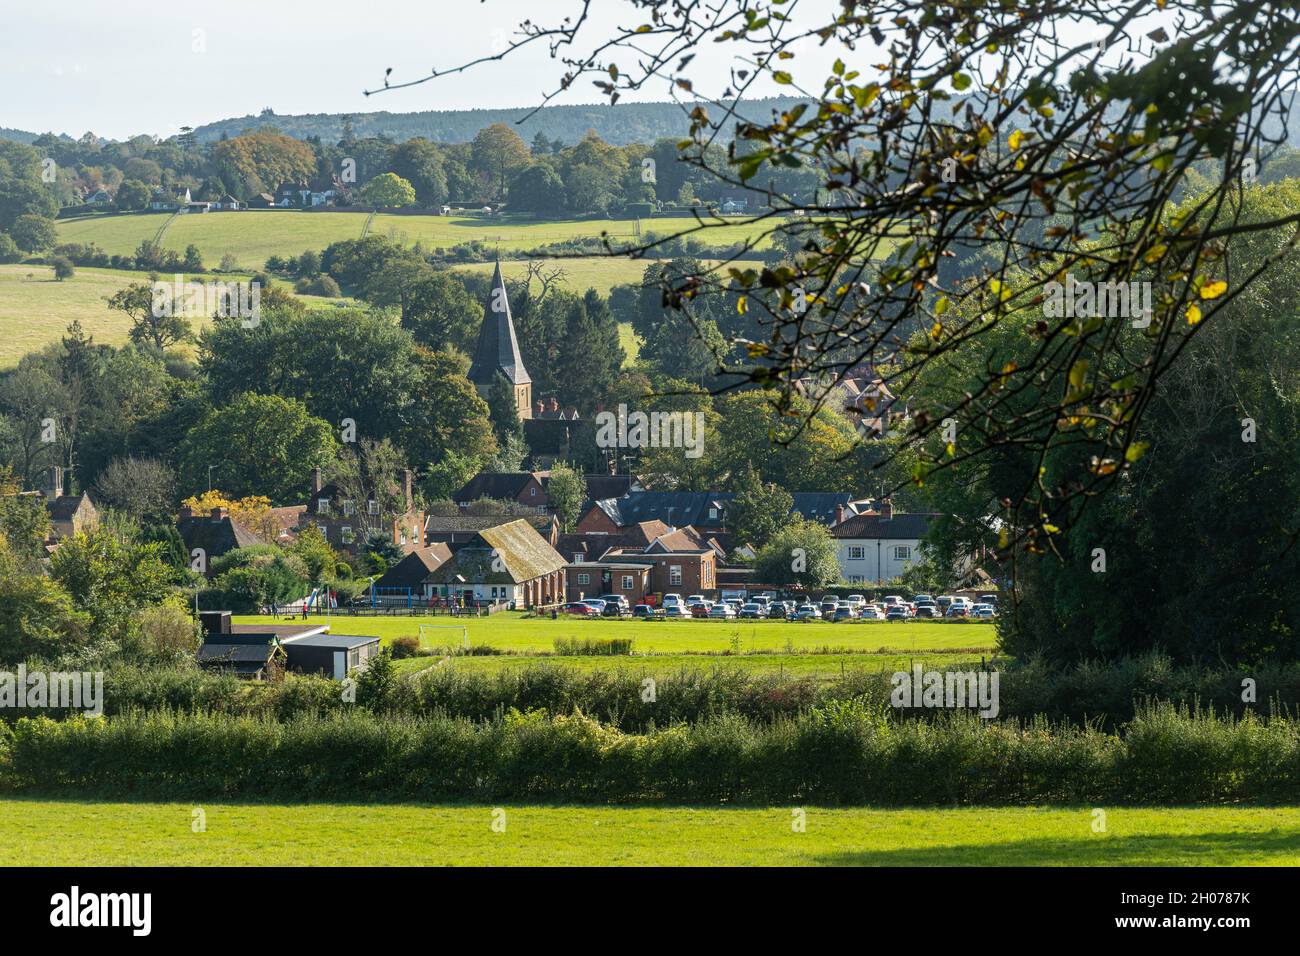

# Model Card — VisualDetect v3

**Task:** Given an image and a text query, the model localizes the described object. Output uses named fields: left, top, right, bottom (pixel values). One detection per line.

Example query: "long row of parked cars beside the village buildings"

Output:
left=563, top=594, right=997, bottom=620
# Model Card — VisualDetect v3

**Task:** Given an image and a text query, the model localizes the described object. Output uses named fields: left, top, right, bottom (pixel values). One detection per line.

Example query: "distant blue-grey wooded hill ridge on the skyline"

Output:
left=194, top=96, right=800, bottom=146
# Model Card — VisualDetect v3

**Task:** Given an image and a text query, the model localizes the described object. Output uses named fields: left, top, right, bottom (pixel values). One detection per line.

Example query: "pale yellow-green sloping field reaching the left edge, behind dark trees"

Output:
left=0, top=263, right=350, bottom=368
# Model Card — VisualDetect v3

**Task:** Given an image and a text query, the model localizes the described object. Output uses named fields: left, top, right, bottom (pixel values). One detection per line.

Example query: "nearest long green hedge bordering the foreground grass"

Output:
left=0, top=700, right=1300, bottom=806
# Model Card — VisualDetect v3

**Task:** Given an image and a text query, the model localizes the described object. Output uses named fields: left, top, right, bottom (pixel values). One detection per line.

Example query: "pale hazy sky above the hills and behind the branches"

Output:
left=0, top=0, right=852, bottom=139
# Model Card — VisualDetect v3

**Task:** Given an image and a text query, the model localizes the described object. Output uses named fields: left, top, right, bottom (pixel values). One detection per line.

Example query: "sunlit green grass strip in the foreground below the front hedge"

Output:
left=0, top=800, right=1300, bottom=866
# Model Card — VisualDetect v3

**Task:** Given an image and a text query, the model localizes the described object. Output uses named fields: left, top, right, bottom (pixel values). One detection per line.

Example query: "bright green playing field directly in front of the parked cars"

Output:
left=235, top=611, right=997, bottom=654
